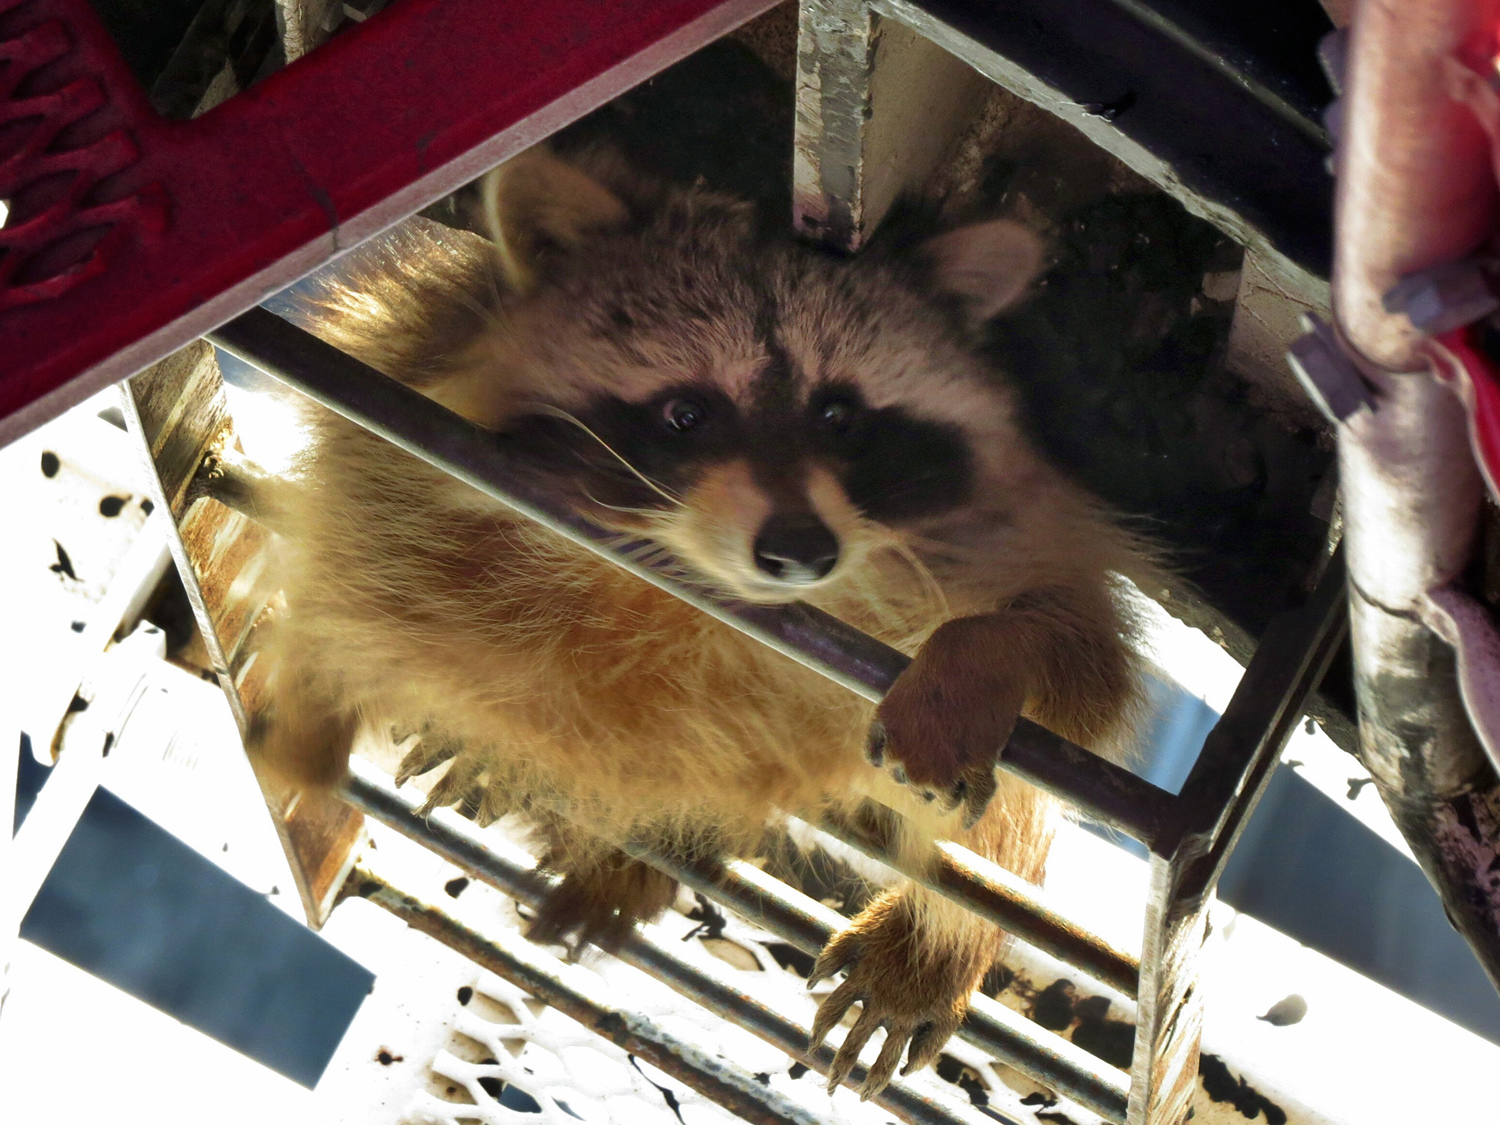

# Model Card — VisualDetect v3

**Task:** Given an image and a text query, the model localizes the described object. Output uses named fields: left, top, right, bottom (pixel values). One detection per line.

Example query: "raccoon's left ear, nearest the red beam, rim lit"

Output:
left=480, top=149, right=630, bottom=293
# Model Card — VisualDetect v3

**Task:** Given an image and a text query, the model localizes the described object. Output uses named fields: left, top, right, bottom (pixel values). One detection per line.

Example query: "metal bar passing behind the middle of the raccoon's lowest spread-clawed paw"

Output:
left=626, top=828, right=1130, bottom=1122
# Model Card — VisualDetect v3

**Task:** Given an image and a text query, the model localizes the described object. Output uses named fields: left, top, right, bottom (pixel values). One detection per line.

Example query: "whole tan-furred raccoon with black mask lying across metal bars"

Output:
left=257, top=150, right=1152, bottom=1097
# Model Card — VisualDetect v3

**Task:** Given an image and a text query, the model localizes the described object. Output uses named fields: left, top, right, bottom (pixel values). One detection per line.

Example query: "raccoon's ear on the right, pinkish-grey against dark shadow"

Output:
left=923, top=219, right=1046, bottom=327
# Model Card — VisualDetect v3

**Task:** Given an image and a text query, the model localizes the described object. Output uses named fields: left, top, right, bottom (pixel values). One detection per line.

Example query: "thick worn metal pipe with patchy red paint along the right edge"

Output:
left=1334, top=0, right=1500, bottom=984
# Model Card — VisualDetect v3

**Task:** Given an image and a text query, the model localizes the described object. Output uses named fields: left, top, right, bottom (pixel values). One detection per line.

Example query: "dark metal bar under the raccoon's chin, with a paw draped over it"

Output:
left=209, top=309, right=1173, bottom=845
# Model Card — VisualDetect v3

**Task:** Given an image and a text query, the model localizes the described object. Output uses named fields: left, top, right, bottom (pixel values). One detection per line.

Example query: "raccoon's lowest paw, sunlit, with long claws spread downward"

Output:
left=807, top=893, right=977, bottom=1101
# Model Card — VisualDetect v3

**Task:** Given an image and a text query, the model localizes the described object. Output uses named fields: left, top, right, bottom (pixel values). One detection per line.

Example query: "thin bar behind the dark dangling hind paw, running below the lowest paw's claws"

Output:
left=344, top=759, right=987, bottom=1125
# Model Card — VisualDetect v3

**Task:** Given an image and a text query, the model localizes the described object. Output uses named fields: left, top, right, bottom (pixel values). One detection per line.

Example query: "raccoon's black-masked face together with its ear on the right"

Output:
left=465, top=156, right=1041, bottom=602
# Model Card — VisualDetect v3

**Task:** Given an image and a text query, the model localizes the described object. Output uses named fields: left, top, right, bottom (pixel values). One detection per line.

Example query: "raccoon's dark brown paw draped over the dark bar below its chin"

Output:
left=866, top=617, right=1026, bottom=828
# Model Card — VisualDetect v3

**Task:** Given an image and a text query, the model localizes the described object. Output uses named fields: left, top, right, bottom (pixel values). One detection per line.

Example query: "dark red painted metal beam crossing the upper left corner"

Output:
left=0, top=0, right=774, bottom=446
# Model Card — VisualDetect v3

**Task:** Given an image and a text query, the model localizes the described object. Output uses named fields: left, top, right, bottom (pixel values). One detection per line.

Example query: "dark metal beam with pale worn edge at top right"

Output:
left=872, top=0, right=1334, bottom=278
